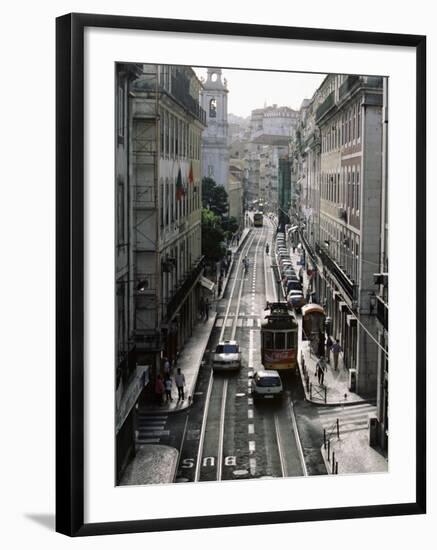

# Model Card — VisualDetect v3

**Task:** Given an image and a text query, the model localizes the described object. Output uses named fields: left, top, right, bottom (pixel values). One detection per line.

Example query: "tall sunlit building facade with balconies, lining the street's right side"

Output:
left=293, top=75, right=384, bottom=398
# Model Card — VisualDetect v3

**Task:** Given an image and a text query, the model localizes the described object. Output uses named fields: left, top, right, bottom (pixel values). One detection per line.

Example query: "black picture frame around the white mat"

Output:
left=56, top=14, right=426, bottom=536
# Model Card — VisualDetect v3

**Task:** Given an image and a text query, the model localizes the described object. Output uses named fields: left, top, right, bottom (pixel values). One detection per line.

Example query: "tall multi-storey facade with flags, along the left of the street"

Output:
left=116, top=64, right=206, bottom=484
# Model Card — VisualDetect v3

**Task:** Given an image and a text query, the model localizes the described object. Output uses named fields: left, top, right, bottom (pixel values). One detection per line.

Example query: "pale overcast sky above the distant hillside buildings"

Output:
left=194, top=67, right=326, bottom=117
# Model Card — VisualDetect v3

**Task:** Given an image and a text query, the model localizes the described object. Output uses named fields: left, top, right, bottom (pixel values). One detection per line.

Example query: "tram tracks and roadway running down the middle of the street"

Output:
left=193, top=220, right=306, bottom=481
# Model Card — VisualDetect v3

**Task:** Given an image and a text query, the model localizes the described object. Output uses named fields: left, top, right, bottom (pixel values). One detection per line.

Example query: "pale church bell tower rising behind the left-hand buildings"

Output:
left=201, top=68, right=229, bottom=190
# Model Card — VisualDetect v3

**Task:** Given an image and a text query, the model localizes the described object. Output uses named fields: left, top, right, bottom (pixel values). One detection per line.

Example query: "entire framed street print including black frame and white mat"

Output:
left=56, top=14, right=426, bottom=536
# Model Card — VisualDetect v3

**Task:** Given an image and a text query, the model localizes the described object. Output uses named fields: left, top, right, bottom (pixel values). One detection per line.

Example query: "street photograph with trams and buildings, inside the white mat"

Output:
left=116, top=62, right=389, bottom=486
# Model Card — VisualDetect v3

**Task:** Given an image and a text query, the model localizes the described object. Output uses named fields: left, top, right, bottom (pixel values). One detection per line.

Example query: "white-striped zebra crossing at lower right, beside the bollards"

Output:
left=317, top=403, right=376, bottom=436
